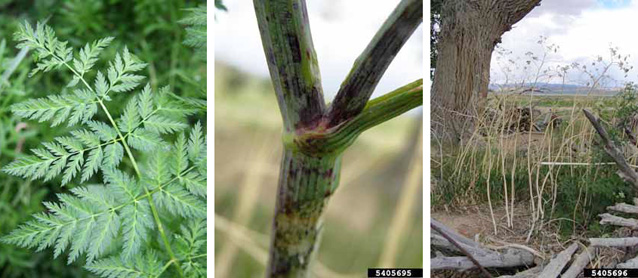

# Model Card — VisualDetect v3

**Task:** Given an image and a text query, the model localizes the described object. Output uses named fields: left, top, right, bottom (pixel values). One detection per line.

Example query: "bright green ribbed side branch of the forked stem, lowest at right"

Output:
left=294, top=79, right=423, bottom=156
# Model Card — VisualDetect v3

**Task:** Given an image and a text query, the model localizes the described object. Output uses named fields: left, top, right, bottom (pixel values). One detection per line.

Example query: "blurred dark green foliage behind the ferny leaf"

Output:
left=0, top=0, right=206, bottom=278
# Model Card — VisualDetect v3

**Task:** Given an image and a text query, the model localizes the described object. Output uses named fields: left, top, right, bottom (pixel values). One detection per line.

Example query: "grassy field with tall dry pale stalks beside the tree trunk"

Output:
left=431, top=88, right=636, bottom=248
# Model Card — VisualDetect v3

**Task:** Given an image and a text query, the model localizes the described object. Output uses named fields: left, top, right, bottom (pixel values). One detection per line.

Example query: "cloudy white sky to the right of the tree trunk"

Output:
left=491, top=0, right=638, bottom=87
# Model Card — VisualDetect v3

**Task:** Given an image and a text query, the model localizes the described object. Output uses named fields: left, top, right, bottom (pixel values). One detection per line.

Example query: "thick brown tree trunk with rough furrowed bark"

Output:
left=431, top=0, right=540, bottom=142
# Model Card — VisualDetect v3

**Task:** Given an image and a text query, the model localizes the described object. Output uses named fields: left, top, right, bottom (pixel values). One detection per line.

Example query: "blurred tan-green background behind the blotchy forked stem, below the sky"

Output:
left=215, top=60, right=423, bottom=278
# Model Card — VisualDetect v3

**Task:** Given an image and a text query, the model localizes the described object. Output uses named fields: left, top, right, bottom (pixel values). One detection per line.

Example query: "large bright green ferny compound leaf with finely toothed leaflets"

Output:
left=0, top=23, right=207, bottom=277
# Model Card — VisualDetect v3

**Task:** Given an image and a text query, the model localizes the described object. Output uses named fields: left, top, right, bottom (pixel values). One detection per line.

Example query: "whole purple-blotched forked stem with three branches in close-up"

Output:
left=254, top=0, right=423, bottom=277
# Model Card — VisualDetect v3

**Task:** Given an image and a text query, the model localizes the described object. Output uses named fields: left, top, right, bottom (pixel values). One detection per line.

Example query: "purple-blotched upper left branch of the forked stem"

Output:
left=254, top=0, right=325, bottom=132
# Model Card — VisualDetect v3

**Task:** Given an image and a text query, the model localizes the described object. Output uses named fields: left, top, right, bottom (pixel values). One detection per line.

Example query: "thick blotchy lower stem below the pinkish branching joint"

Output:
left=267, top=148, right=341, bottom=277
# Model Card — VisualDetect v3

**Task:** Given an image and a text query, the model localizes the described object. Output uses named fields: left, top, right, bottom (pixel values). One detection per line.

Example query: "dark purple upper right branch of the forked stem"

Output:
left=328, top=0, right=423, bottom=127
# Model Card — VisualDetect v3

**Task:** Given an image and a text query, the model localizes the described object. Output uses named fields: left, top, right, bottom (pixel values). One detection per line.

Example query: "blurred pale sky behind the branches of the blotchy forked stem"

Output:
left=215, top=0, right=427, bottom=101
